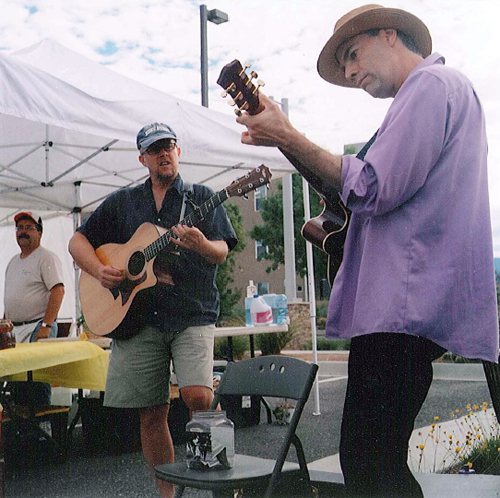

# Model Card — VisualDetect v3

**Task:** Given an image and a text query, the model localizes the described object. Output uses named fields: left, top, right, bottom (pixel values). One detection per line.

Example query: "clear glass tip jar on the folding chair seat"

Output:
left=186, top=410, right=234, bottom=470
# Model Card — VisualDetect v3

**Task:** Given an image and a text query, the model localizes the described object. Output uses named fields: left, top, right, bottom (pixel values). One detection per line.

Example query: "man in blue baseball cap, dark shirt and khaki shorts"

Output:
left=69, top=123, right=237, bottom=497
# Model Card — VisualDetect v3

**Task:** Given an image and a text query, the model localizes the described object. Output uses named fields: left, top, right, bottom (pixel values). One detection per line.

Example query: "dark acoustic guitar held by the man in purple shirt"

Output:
left=217, top=60, right=350, bottom=285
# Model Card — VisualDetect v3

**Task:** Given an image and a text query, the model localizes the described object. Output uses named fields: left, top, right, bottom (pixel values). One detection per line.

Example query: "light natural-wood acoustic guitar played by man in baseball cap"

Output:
left=80, top=165, right=271, bottom=338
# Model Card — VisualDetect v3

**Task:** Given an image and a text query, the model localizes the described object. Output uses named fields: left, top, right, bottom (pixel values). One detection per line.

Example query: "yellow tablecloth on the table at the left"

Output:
left=0, top=341, right=109, bottom=391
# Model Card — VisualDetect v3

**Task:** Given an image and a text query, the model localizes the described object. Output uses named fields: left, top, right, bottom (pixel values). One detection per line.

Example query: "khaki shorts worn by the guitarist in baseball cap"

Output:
left=104, top=325, right=215, bottom=408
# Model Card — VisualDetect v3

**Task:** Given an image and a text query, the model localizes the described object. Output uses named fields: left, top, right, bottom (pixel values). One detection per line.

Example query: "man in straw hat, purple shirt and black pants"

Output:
left=237, top=5, right=498, bottom=498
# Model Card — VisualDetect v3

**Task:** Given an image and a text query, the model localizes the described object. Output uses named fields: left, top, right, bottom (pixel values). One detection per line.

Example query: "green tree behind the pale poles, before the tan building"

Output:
left=249, top=174, right=328, bottom=285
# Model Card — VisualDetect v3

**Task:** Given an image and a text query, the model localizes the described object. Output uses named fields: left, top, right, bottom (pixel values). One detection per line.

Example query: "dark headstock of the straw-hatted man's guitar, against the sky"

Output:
left=217, top=59, right=264, bottom=114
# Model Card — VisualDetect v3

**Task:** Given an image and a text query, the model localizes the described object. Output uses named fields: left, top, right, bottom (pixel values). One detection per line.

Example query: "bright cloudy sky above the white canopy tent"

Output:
left=0, top=0, right=500, bottom=257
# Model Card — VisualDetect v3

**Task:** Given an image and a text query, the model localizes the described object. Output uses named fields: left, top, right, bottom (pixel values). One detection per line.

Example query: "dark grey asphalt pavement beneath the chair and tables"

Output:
left=2, top=364, right=491, bottom=498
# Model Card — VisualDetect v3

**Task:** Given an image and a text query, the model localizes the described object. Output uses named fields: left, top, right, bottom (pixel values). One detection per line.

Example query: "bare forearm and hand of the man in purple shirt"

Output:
left=236, top=93, right=342, bottom=194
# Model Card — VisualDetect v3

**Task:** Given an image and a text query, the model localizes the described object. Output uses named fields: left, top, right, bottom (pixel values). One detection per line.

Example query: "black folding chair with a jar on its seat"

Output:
left=156, top=356, right=318, bottom=498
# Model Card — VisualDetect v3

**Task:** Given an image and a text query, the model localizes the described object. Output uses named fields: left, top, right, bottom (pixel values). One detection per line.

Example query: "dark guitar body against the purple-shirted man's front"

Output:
left=301, top=198, right=349, bottom=286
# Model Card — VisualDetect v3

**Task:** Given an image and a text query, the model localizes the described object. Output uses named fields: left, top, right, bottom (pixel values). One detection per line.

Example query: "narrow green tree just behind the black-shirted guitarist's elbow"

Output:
left=216, top=203, right=246, bottom=322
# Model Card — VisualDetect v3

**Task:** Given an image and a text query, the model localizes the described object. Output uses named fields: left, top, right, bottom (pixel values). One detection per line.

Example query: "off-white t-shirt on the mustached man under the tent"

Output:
left=4, top=246, right=63, bottom=322
